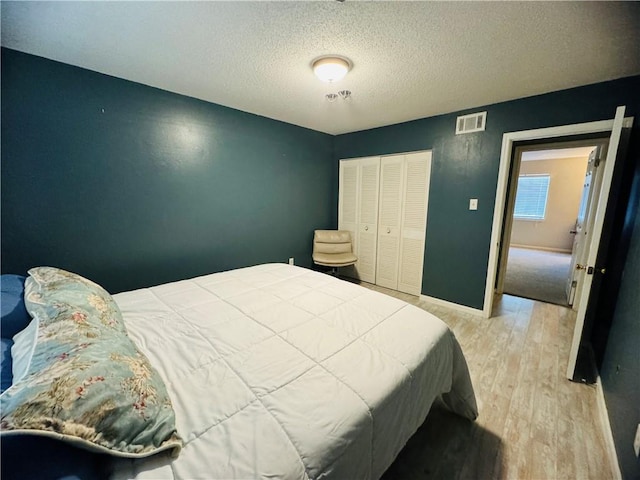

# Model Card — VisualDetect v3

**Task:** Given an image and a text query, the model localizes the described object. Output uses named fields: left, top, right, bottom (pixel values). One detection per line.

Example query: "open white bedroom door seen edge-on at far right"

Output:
left=567, top=107, right=631, bottom=379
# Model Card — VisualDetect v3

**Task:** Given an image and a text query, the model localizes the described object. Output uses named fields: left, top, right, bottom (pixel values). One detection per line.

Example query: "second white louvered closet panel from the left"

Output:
left=356, top=157, right=380, bottom=283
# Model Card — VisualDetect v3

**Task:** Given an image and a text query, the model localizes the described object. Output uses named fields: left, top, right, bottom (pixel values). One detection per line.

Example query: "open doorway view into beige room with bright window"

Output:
left=500, top=140, right=603, bottom=306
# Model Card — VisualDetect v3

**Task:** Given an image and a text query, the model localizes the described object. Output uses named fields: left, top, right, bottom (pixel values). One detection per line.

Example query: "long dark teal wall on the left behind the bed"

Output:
left=1, top=49, right=337, bottom=292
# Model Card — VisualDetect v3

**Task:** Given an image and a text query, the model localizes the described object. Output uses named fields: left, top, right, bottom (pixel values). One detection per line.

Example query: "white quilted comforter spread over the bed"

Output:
left=109, top=264, right=477, bottom=479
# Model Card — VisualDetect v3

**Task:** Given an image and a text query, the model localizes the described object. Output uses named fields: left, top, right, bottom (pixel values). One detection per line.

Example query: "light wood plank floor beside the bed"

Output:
left=362, top=283, right=615, bottom=480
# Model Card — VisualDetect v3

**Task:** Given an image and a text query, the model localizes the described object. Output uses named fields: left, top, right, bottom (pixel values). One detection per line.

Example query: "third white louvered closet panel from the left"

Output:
left=376, top=155, right=404, bottom=290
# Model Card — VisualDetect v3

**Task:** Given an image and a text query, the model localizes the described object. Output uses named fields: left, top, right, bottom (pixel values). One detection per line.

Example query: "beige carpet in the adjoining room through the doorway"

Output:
left=504, top=247, right=571, bottom=305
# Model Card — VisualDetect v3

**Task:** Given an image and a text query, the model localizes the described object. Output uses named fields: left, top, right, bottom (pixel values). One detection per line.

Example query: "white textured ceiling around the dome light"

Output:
left=0, top=0, right=640, bottom=134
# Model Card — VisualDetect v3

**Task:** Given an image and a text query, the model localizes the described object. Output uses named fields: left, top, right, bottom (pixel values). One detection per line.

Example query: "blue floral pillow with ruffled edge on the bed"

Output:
left=0, top=267, right=182, bottom=457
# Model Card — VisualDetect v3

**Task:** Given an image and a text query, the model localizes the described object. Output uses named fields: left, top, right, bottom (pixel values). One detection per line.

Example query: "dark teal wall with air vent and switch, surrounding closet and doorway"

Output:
left=335, top=76, right=640, bottom=309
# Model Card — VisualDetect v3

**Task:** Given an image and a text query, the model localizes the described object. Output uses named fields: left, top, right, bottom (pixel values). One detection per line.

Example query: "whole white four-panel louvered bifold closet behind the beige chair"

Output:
left=338, top=151, right=431, bottom=295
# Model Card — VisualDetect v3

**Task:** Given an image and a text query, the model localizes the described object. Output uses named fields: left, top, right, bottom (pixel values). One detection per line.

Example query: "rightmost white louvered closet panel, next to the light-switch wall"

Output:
left=398, top=152, right=431, bottom=295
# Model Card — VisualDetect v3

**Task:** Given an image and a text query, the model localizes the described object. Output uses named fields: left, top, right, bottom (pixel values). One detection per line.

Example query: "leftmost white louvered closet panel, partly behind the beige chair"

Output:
left=338, top=160, right=359, bottom=277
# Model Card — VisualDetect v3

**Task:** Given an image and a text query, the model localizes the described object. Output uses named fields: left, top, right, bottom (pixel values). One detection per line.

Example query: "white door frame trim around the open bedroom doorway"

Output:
left=482, top=114, right=633, bottom=318
